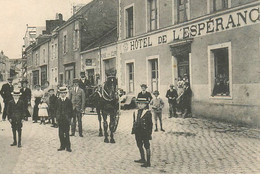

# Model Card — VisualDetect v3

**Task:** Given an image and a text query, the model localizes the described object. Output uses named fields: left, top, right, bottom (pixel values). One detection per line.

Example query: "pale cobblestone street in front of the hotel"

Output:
left=0, top=111, right=260, bottom=174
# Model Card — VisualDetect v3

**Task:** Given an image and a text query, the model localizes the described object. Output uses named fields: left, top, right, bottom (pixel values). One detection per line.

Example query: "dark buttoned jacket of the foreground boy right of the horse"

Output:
left=134, top=109, right=153, bottom=138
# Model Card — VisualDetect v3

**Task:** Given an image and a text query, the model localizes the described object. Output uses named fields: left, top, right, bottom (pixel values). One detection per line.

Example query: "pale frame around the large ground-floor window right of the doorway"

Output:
left=208, top=42, right=233, bottom=100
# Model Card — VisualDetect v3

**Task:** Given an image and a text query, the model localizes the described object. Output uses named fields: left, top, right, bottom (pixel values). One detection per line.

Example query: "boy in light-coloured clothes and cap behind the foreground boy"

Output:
left=150, top=90, right=165, bottom=132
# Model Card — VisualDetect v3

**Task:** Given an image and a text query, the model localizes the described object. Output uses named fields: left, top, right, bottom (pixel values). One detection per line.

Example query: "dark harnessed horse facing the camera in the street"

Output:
left=90, top=76, right=119, bottom=143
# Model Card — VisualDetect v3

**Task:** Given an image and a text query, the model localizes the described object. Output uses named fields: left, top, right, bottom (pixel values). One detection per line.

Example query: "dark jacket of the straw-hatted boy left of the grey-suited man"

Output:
left=56, top=98, right=73, bottom=124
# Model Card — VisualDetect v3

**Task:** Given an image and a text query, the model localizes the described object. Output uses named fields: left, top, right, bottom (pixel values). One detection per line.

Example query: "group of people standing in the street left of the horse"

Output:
left=0, top=72, right=88, bottom=152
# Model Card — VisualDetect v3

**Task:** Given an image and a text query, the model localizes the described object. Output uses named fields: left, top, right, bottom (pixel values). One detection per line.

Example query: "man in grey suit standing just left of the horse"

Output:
left=70, top=79, right=85, bottom=137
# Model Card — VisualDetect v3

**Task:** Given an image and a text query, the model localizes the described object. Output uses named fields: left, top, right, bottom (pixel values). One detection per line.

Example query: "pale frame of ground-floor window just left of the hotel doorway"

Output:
left=146, top=54, right=161, bottom=92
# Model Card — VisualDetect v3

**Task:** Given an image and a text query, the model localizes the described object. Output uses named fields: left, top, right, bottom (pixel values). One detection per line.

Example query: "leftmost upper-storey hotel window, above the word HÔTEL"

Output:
left=126, top=7, right=134, bottom=38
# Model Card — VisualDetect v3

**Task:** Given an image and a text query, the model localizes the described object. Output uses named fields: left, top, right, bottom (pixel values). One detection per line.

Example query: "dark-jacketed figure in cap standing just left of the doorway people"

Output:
left=166, top=84, right=178, bottom=118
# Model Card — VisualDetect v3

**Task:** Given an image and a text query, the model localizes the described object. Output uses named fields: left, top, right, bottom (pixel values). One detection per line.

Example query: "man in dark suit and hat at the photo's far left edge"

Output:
left=0, top=78, right=14, bottom=121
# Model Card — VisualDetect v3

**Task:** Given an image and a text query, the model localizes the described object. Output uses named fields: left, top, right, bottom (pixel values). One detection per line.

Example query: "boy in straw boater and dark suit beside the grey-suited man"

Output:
left=56, top=87, right=73, bottom=152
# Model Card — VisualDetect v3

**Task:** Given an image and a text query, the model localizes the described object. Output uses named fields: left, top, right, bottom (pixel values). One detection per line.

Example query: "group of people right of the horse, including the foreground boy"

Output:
left=132, top=77, right=191, bottom=167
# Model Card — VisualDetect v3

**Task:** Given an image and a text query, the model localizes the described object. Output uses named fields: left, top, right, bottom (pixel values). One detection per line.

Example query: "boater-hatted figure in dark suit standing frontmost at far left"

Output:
left=7, top=90, right=26, bottom=148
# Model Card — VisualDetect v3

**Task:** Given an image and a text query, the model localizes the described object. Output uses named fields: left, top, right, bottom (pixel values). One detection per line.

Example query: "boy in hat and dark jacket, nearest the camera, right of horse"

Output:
left=133, top=98, right=153, bottom=167
